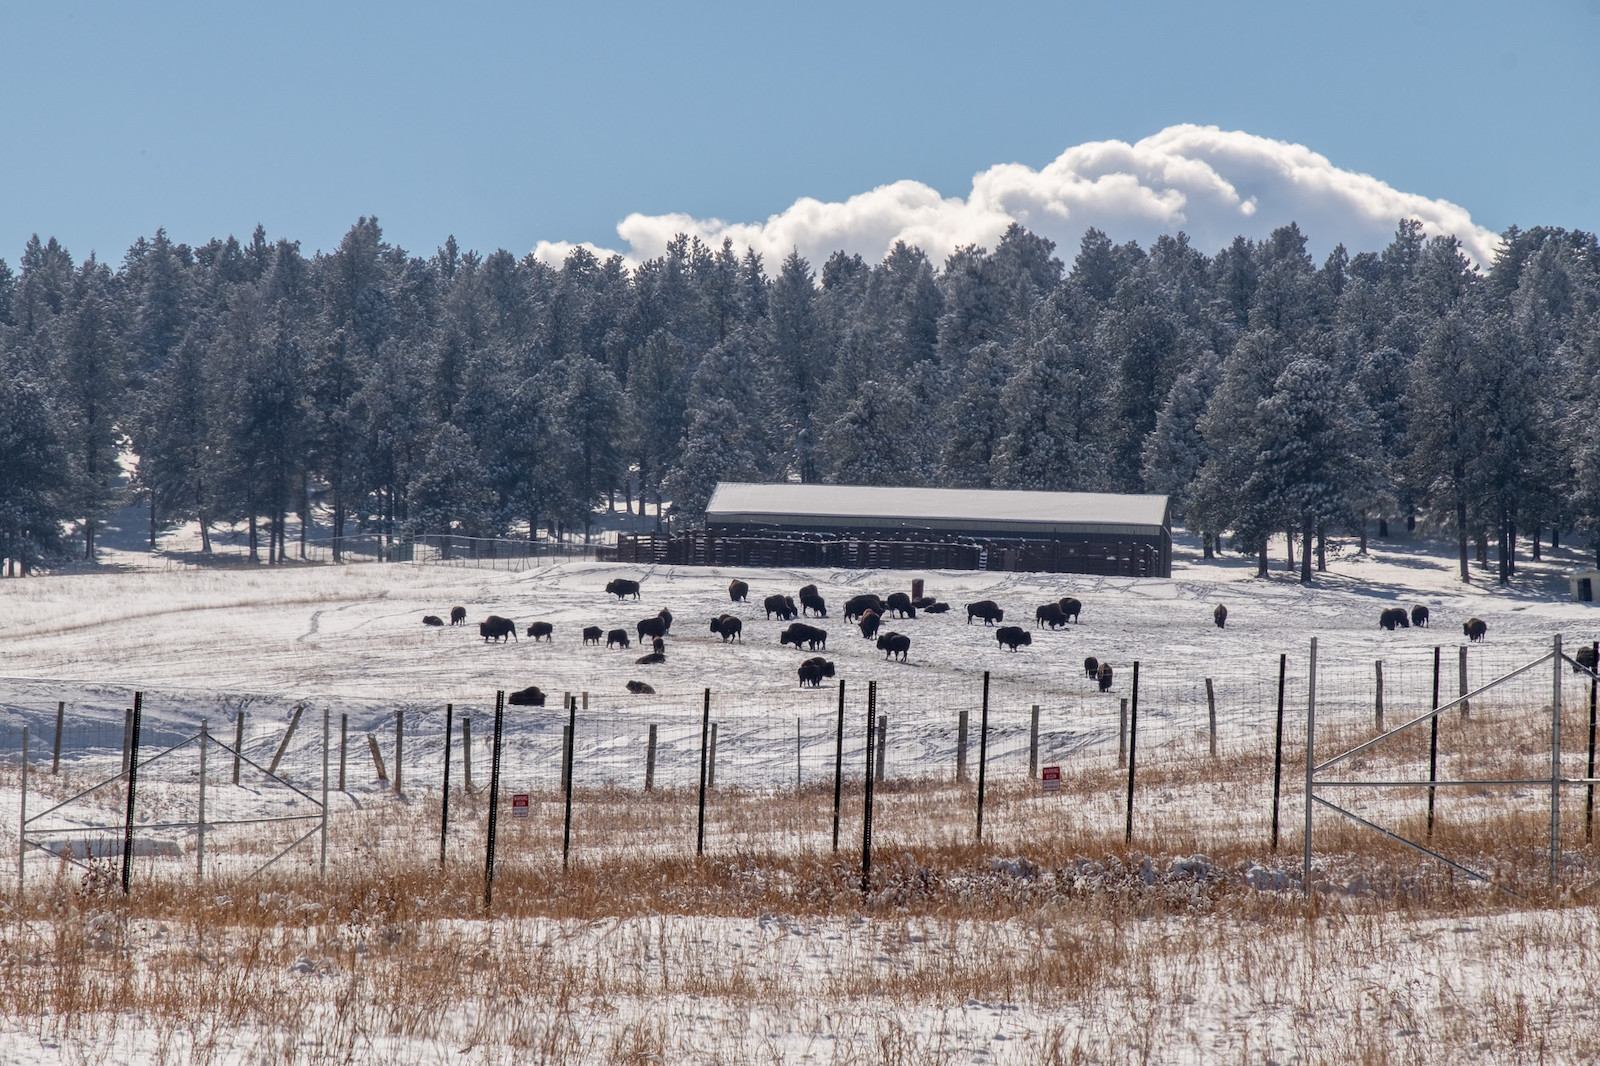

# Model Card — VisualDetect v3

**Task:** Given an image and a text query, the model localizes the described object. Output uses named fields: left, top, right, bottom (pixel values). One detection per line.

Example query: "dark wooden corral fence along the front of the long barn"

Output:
left=598, top=530, right=1166, bottom=578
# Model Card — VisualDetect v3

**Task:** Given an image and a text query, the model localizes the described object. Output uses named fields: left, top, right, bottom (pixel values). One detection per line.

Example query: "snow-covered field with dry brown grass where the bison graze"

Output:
left=0, top=538, right=1600, bottom=1063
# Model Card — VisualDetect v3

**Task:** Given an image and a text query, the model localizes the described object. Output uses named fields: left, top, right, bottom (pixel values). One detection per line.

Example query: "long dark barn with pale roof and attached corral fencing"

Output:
left=604, top=482, right=1173, bottom=578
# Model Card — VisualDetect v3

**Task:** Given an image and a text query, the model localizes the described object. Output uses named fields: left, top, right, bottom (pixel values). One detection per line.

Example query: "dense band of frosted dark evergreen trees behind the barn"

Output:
left=0, top=219, right=1600, bottom=581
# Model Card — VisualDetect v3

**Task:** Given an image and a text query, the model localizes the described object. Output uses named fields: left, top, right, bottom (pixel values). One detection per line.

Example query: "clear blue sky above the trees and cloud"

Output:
left=0, top=0, right=1600, bottom=264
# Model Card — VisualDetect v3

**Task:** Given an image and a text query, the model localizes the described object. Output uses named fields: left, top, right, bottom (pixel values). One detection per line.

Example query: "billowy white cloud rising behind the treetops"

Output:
left=534, top=125, right=1499, bottom=269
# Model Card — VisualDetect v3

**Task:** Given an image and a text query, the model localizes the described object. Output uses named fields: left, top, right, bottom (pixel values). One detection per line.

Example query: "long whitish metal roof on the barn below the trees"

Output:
left=706, top=482, right=1168, bottom=536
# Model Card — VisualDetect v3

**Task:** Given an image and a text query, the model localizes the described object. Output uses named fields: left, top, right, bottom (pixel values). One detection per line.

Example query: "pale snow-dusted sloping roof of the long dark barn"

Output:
left=706, top=482, right=1166, bottom=528
